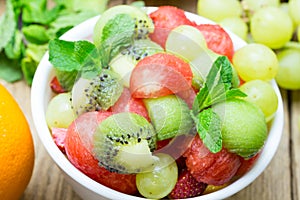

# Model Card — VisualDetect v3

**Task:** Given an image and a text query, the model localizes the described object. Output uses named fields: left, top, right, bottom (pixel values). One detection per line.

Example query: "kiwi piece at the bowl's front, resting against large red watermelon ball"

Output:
left=94, top=112, right=156, bottom=174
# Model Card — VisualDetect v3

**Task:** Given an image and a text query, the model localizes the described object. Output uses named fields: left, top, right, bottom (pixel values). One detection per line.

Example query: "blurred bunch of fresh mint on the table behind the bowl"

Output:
left=0, top=0, right=108, bottom=85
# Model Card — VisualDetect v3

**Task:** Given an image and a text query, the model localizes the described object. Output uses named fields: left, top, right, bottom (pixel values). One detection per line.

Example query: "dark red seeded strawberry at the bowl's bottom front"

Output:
left=168, top=169, right=207, bottom=199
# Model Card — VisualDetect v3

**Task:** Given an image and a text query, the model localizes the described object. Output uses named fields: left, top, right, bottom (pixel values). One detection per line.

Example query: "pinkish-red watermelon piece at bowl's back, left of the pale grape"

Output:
left=150, top=6, right=195, bottom=47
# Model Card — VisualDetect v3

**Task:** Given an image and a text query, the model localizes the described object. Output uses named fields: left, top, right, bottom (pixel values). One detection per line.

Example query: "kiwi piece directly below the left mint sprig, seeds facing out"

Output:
left=71, top=69, right=123, bottom=115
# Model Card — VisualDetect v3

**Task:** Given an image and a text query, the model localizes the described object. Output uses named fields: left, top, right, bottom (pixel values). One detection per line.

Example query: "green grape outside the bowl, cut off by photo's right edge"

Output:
left=275, top=49, right=300, bottom=90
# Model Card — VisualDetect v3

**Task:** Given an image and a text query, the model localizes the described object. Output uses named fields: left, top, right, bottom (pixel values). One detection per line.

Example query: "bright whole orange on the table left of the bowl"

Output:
left=0, top=84, right=35, bottom=200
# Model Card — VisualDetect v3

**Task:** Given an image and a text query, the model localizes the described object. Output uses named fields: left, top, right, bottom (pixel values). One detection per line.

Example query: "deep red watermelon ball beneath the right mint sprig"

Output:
left=184, top=135, right=241, bottom=185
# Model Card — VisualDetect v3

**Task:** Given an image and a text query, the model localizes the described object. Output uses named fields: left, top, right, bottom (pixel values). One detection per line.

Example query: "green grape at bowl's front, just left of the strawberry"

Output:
left=136, top=153, right=178, bottom=199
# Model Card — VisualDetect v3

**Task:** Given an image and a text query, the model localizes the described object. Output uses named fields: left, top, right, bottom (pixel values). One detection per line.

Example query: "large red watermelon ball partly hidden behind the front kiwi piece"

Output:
left=65, top=112, right=137, bottom=194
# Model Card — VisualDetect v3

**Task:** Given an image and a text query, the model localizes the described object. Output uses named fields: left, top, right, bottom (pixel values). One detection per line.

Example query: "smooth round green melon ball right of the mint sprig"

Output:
left=213, top=99, right=267, bottom=158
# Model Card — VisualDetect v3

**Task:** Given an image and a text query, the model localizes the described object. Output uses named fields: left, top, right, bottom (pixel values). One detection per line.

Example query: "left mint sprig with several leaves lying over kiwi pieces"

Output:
left=49, top=14, right=135, bottom=90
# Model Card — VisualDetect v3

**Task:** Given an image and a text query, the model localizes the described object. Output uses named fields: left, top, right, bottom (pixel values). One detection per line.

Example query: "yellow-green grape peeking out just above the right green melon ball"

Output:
left=240, top=80, right=278, bottom=122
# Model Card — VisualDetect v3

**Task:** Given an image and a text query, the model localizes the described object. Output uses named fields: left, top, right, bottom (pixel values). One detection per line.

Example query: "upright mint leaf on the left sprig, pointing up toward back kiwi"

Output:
left=99, top=14, right=135, bottom=67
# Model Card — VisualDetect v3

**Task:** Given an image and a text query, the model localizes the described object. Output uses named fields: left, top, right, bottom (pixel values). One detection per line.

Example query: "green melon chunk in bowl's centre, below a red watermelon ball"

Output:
left=144, top=95, right=193, bottom=140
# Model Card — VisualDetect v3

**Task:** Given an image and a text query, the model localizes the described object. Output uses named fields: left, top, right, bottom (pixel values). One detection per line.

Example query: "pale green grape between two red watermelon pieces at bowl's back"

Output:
left=166, top=25, right=207, bottom=61
